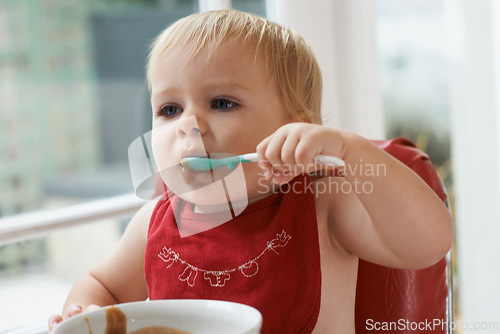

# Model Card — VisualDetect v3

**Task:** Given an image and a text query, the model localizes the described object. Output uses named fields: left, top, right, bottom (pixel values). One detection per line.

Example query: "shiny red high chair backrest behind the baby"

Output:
left=355, top=138, right=452, bottom=334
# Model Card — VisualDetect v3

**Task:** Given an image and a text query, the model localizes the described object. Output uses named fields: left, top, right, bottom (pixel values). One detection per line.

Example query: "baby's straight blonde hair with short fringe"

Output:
left=147, top=9, right=322, bottom=124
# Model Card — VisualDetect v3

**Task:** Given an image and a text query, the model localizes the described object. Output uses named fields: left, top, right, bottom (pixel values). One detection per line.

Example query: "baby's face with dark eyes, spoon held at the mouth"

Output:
left=151, top=42, right=291, bottom=203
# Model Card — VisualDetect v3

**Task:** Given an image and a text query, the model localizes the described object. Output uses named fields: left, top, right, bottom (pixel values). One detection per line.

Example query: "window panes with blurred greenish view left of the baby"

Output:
left=0, top=0, right=198, bottom=331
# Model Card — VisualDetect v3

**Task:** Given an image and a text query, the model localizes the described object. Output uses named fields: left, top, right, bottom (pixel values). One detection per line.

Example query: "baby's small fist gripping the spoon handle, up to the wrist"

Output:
left=257, top=123, right=344, bottom=184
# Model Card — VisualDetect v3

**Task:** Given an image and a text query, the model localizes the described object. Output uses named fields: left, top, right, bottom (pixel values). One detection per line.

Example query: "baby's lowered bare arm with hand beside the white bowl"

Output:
left=49, top=202, right=156, bottom=328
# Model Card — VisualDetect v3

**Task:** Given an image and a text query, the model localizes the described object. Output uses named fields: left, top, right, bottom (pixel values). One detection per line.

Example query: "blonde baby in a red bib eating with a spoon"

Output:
left=49, top=10, right=453, bottom=334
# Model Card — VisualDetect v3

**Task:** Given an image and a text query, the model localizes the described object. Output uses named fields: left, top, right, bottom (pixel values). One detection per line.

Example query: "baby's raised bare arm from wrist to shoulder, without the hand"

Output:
left=329, top=134, right=453, bottom=269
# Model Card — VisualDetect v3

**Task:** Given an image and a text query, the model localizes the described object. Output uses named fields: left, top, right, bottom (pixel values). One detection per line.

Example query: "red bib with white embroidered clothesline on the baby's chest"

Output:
left=144, top=176, right=321, bottom=334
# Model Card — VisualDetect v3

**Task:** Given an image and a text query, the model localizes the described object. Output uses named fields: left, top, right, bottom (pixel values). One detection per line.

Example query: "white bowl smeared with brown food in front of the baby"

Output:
left=51, top=299, right=262, bottom=334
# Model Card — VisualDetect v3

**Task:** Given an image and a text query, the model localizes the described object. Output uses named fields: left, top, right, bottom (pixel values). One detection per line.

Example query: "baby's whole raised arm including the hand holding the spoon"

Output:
left=257, top=123, right=453, bottom=269
